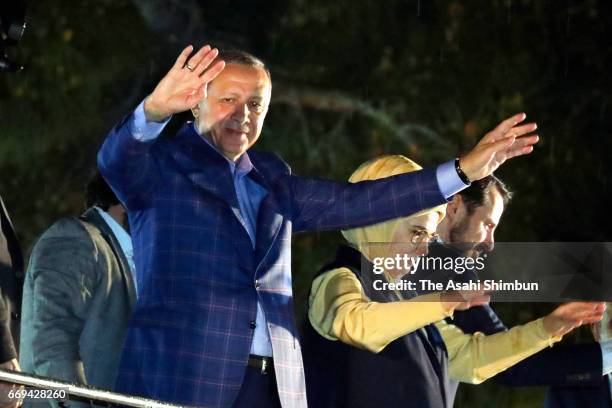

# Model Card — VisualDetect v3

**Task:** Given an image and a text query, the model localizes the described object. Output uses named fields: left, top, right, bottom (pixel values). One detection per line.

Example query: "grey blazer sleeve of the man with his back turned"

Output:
left=27, top=230, right=97, bottom=384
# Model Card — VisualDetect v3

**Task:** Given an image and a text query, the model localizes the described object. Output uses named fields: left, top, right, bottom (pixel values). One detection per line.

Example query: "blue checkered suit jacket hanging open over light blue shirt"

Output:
left=98, top=117, right=445, bottom=407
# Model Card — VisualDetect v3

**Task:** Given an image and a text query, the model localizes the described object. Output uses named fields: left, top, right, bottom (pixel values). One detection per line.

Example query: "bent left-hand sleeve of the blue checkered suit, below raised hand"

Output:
left=98, top=113, right=160, bottom=210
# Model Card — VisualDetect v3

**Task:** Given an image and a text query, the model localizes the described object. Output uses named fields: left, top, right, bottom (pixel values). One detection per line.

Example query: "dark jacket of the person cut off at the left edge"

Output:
left=0, top=198, right=23, bottom=363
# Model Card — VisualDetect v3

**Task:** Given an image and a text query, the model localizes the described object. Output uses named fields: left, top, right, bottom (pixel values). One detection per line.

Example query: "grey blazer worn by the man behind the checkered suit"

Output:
left=20, top=208, right=136, bottom=404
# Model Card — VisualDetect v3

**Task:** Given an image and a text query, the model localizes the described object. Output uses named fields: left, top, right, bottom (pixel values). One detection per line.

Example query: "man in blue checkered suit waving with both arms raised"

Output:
left=98, top=46, right=537, bottom=407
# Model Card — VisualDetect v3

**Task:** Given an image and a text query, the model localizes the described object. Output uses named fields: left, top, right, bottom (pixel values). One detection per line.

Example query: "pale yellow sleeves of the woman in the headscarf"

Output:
left=308, top=268, right=561, bottom=384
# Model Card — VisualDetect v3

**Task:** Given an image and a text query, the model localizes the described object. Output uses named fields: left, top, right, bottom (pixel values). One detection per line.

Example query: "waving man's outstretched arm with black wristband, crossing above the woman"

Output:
left=290, top=114, right=538, bottom=232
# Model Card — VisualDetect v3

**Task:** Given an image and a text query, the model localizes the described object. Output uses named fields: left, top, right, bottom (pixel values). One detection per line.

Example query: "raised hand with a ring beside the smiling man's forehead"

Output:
left=144, top=45, right=225, bottom=122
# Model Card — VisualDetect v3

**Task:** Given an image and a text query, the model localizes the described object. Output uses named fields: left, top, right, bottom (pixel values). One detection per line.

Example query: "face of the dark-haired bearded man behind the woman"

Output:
left=449, top=188, right=504, bottom=257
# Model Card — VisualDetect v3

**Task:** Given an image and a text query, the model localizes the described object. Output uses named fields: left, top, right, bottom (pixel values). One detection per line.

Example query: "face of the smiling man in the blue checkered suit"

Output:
left=193, top=64, right=272, bottom=161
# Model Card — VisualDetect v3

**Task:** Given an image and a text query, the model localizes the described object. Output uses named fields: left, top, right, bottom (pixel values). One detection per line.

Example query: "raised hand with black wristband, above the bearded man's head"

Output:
left=459, top=113, right=539, bottom=181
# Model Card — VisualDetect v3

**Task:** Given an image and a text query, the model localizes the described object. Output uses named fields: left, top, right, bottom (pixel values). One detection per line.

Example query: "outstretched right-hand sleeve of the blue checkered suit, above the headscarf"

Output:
left=286, top=169, right=446, bottom=232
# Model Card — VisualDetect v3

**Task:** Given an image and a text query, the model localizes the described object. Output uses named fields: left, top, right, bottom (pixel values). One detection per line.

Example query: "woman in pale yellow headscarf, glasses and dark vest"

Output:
left=302, top=156, right=603, bottom=408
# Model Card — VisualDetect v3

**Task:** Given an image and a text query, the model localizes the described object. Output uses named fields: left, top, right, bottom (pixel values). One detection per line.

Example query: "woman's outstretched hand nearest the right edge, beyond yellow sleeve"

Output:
left=544, top=302, right=606, bottom=336
